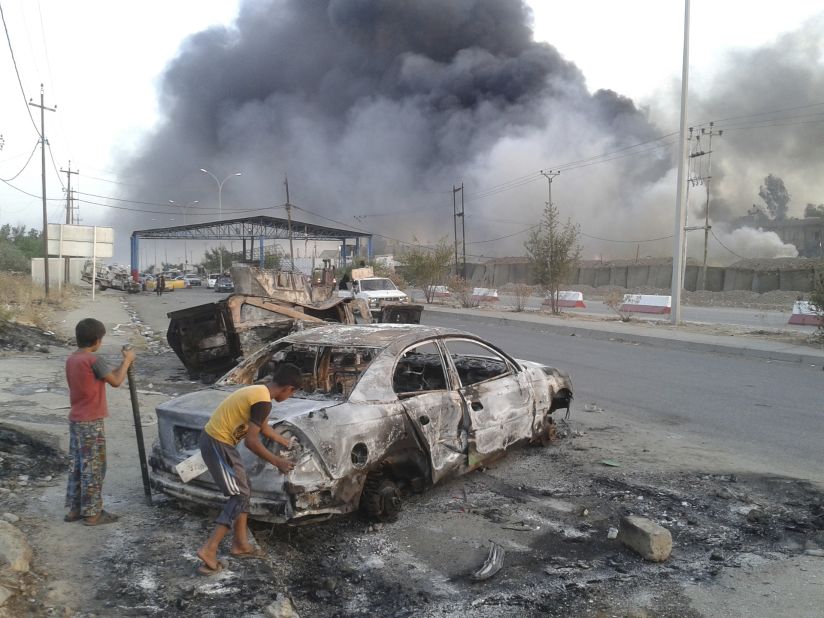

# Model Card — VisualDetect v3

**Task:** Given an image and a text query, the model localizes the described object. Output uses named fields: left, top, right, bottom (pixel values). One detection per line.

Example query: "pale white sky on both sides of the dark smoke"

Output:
left=0, top=0, right=824, bottom=264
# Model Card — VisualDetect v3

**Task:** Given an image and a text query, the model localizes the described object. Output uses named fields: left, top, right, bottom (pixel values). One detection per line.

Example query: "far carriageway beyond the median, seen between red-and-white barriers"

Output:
left=413, top=290, right=816, bottom=333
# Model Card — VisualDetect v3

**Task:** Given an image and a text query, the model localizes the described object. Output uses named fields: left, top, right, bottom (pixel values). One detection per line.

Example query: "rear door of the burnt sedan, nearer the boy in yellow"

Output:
left=392, top=340, right=468, bottom=483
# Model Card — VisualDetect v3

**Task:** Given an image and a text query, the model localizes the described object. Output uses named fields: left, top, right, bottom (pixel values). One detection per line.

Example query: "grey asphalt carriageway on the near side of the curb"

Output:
left=129, top=289, right=824, bottom=480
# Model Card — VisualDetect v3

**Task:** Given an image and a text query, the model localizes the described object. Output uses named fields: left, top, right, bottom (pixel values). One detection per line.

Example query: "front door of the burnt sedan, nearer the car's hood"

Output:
left=443, top=337, right=533, bottom=466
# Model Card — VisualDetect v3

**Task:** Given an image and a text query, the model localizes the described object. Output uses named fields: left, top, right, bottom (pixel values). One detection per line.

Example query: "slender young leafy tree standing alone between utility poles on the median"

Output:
left=524, top=204, right=581, bottom=314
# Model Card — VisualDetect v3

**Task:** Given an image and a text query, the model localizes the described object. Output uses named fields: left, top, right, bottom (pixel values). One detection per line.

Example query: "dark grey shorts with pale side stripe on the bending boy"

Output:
left=200, top=431, right=252, bottom=527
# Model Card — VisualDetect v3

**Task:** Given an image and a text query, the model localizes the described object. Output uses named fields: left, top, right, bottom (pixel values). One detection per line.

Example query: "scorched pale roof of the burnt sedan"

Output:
left=282, top=324, right=464, bottom=348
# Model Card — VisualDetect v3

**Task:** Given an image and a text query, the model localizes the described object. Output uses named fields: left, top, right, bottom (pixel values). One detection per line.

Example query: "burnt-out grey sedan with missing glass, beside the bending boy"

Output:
left=149, top=324, right=573, bottom=523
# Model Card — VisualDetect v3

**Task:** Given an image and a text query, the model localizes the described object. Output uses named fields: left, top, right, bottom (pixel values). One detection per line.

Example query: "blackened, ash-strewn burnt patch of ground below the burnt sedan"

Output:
left=56, top=428, right=824, bottom=617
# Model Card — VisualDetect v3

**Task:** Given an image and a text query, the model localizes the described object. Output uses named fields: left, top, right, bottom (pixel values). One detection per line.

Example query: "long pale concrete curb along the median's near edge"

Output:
left=424, top=306, right=824, bottom=365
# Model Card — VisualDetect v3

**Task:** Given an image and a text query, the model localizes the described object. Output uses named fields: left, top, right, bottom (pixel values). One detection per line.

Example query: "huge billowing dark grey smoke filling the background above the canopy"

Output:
left=117, top=0, right=824, bottom=257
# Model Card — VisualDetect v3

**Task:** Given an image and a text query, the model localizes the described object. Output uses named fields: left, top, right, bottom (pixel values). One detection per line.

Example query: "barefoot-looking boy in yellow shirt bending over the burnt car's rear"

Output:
left=197, top=363, right=302, bottom=575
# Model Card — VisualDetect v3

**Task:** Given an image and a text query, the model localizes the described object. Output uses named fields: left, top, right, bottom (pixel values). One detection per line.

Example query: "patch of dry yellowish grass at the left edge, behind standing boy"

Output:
left=0, top=272, right=74, bottom=328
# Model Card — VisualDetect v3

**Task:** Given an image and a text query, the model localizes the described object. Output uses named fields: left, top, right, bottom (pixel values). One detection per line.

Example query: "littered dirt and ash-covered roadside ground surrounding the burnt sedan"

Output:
left=0, top=292, right=824, bottom=618
